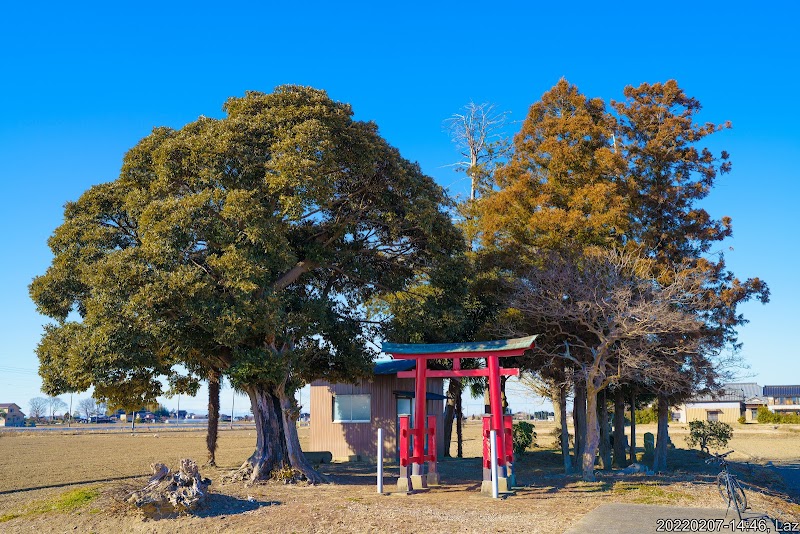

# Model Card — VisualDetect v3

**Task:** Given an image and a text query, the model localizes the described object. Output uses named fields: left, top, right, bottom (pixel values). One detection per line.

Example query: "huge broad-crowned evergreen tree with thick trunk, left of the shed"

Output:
left=31, top=86, right=462, bottom=481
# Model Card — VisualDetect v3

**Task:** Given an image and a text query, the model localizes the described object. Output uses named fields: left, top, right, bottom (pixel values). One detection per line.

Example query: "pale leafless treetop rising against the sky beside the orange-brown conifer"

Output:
left=444, top=102, right=509, bottom=200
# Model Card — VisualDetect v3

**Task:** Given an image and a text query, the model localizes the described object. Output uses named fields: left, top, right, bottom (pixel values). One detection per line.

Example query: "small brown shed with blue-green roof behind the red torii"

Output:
left=309, top=360, right=447, bottom=461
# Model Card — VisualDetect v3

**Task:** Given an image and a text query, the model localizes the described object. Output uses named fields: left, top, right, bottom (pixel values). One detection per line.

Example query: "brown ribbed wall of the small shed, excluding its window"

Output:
left=309, top=375, right=444, bottom=460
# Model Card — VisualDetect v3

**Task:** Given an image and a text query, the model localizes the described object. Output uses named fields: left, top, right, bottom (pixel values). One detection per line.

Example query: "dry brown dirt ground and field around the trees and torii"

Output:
left=0, top=423, right=800, bottom=533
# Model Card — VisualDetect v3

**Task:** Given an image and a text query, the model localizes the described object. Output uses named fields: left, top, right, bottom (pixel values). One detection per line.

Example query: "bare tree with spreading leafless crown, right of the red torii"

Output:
left=514, top=249, right=703, bottom=480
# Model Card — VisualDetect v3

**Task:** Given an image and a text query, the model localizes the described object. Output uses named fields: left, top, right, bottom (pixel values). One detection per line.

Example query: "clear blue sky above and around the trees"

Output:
left=0, top=1, right=800, bottom=412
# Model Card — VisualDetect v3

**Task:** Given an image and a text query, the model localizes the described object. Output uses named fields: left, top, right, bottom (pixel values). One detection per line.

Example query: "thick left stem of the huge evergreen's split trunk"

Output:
left=240, top=386, right=289, bottom=482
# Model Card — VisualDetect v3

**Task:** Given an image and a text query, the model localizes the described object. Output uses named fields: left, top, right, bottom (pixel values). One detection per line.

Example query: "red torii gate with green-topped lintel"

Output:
left=381, top=335, right=537, bottom=492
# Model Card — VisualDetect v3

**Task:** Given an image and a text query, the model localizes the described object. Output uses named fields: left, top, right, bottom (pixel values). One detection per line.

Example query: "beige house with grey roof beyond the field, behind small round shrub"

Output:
left=679, top=382, right=766, bottom=423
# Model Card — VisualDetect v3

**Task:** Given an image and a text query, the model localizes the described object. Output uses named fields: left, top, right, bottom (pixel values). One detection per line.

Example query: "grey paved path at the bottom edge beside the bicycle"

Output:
left=566, top=504, right=775, bottom=534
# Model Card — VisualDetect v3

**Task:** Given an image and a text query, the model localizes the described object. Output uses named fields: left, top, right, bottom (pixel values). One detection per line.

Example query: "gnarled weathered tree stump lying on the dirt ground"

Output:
left=128, top=458, right=211, bottom=519
